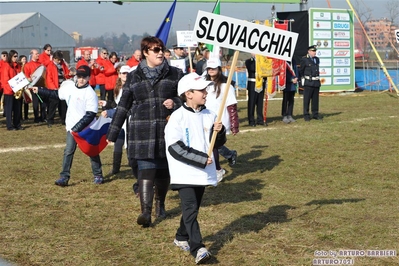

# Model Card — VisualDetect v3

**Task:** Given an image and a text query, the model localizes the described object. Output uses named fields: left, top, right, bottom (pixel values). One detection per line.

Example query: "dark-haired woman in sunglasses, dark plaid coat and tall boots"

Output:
left=107, top=37, right=183, bottom=227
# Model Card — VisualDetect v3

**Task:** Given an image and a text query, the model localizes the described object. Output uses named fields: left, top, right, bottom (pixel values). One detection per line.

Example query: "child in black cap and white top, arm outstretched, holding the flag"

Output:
left=32, top=65, right=104, bottom=187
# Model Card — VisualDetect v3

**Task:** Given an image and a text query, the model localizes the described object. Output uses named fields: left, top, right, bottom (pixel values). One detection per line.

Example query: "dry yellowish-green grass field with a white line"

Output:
left=0, top=92, right=399, bottom=266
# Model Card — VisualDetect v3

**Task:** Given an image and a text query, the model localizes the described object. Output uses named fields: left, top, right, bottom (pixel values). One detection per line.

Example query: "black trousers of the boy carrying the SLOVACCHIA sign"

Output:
left=176, top=186, right=205, bottom=257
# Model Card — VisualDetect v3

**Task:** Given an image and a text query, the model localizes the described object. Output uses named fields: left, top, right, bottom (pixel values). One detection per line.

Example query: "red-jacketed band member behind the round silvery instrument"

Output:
left=23, top=49, right=46, bottom=123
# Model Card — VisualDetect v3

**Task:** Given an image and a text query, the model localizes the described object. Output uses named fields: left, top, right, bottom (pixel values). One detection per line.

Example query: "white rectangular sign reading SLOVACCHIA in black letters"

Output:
left=194, top=10, right=298, bottom=61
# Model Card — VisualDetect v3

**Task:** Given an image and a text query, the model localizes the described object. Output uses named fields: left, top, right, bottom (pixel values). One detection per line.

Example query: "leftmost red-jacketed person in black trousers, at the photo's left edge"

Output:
left=1, top=50, right=24, bottom=130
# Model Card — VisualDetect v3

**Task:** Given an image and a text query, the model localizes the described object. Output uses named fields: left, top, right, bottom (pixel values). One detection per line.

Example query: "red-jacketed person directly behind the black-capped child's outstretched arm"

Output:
left=46, top=50, right=70, bottom=127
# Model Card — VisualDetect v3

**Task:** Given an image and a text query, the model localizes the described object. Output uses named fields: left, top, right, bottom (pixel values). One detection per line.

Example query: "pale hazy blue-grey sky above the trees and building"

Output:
left=0, top=0, right=392, bottom=39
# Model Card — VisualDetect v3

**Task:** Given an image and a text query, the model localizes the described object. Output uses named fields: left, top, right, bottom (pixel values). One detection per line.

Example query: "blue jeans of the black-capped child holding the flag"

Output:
left=60, top=131, right=103, bottom=178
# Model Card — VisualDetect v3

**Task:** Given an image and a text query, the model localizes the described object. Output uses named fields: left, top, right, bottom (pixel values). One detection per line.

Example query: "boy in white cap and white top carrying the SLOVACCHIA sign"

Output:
left=165, top=73, right=226, bottom=264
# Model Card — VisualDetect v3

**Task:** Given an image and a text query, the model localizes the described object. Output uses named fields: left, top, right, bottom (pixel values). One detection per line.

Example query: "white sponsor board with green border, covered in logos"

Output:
left=309, top=8, right=355, bottom=92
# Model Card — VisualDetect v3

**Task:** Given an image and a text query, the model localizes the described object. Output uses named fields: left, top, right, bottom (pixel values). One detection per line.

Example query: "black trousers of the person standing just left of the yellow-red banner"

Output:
left=247, top=81, right=265, bottom=125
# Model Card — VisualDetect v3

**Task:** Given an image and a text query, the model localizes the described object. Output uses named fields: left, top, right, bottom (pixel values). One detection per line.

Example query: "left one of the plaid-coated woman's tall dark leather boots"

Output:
left=137, top=179, right=154, bottom=227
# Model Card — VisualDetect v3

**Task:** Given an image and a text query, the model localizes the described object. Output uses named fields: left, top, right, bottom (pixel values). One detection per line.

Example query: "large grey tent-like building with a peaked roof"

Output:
left=0, top=12, right=76, bottom=63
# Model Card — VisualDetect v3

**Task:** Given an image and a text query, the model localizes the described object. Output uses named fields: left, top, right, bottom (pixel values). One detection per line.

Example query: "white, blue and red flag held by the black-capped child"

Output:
left=71, top=116, right=112, bottom=157
